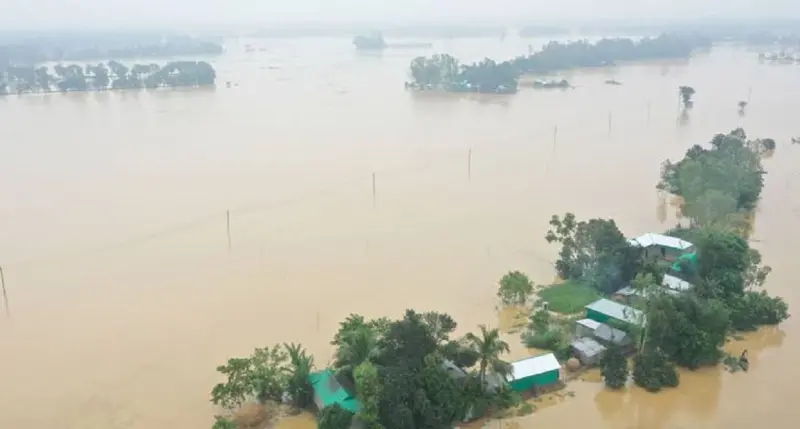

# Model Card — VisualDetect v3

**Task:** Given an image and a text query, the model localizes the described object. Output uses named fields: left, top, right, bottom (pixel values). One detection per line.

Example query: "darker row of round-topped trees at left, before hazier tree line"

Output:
left=0, top=61, right=217, bottom=95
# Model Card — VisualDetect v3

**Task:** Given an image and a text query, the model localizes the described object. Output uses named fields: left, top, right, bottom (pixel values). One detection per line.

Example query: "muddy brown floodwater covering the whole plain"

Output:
left=0, top=39, right=800, bottom=429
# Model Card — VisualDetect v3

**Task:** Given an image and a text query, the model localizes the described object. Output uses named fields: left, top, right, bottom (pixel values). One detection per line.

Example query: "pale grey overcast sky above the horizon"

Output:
left=0, top=0, right=800, bottom=29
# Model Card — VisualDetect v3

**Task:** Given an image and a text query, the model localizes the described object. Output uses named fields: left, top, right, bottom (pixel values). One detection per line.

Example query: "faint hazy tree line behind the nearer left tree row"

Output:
left=0, top=33, right=223, bottom=67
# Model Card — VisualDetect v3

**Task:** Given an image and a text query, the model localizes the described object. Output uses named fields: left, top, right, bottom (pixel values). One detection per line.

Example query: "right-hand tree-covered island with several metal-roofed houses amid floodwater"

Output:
left=504, top=129, right=789, bottom=392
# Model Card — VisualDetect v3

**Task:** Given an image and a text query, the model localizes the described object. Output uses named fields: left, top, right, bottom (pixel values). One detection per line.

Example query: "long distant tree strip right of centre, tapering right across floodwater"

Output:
left=407, top=34, right=710, bottom=93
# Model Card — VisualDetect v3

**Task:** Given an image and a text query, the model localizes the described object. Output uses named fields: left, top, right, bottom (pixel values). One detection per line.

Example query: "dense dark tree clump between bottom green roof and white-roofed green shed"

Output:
left=334, top=310, right=509, bottom=429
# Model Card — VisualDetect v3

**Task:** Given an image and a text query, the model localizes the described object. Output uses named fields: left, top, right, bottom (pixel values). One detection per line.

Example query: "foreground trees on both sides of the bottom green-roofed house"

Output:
left=211, top=310, right=519, bottom=429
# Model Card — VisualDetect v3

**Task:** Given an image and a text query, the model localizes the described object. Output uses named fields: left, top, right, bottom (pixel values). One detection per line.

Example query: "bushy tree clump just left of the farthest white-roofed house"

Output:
left=545, top=213, right=642, bottom=294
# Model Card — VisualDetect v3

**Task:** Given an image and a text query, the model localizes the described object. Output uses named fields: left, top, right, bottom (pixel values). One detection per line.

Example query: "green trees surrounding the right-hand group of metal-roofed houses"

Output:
left=532, top=129, right=789, bottom=391
